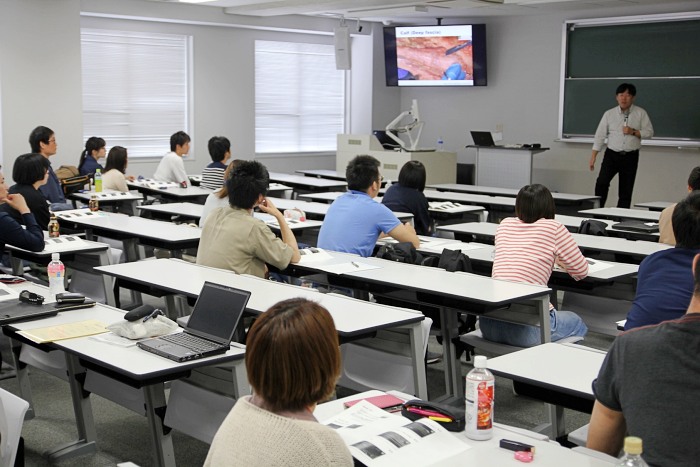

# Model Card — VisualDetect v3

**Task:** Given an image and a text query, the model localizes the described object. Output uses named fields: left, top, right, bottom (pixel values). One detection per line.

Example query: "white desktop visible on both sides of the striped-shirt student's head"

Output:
left=437, top=222, right=673, bottom=260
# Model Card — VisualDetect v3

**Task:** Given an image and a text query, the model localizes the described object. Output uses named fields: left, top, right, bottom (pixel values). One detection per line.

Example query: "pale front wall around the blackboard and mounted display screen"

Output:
left=401, top=4, right=700, bottom=205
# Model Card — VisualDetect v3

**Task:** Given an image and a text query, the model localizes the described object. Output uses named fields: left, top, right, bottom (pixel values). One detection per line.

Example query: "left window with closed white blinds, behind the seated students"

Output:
left=80, top=29, right=189, bottom=158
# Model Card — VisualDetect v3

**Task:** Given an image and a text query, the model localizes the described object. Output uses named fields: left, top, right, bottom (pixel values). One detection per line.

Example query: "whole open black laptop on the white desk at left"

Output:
left=136, top=282, right=250, bottom=362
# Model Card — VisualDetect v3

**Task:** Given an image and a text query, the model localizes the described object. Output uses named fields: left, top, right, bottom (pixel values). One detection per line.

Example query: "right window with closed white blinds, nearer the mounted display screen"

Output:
left=255, top=41, right=345, bottom=153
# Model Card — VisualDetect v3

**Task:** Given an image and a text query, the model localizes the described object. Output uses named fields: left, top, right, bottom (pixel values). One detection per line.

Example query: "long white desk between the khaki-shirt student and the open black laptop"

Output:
left=97, top=259, right=428, bottom=399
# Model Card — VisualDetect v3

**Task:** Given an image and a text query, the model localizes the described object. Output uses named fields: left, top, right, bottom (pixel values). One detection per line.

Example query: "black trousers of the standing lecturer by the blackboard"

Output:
left=595, top=149, right=639, bottom=208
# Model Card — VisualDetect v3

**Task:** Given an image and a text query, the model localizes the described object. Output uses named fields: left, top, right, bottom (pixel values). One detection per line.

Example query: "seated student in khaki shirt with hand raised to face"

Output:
left=197, top=161, right=301, bottom=277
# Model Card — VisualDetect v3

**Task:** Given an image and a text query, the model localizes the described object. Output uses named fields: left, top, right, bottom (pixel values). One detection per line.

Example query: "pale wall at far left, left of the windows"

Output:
left=0, top=0, right=83, bottom=182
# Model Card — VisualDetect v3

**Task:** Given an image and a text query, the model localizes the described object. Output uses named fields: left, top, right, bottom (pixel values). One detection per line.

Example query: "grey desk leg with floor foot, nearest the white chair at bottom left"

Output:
left=43, top=353, right=97, bottom=462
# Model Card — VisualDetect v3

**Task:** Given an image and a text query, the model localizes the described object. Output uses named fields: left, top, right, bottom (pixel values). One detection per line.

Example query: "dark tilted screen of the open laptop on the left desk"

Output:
left=187, top=282, right=250, bottom=341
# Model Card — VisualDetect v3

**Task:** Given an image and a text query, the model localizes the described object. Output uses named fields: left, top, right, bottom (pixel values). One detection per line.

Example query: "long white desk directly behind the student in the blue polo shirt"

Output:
left=278, top=251, right=551, bottom=403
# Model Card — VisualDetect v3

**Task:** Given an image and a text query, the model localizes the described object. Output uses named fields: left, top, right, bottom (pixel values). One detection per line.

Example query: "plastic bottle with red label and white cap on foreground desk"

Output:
left=464, top=355, right=495, bottom=441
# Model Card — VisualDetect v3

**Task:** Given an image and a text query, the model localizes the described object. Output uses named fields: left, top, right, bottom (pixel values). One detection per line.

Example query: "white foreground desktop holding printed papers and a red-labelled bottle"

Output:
left=314, top=392, right=614, bottom=467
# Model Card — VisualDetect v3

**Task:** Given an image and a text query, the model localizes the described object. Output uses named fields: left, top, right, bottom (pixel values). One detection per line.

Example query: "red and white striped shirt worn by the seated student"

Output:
left=491, top=217, right=588, bottom=309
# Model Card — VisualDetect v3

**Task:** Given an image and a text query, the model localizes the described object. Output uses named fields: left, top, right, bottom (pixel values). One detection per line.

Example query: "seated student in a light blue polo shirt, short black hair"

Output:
left=318, top=156, right=420, bottom=257
